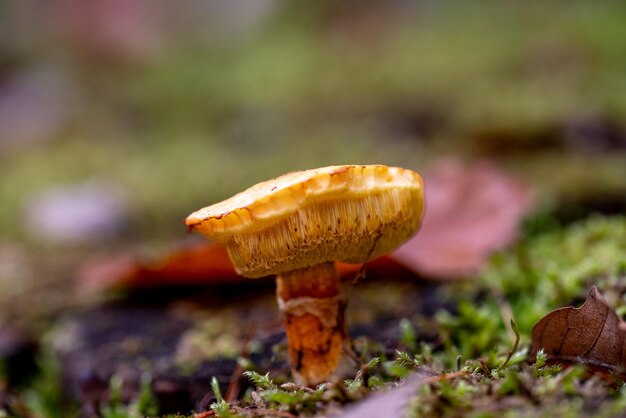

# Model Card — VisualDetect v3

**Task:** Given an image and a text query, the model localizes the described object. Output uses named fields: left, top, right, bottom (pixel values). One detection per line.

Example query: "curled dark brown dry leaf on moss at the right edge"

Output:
left=532, top=286, right=626, bottom=375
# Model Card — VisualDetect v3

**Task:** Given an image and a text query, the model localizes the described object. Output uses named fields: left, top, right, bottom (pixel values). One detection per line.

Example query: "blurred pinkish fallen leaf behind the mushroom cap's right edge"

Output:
left=392, top=159, right=534, bottom=280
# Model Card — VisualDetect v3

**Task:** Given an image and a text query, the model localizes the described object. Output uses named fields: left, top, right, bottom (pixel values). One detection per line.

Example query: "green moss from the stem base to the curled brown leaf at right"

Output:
left=213, top=217, right=626, bottom=417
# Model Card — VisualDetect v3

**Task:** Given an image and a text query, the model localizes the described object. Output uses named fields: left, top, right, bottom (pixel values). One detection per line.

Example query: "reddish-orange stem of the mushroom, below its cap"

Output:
left=276, top=263, right=349, bottom=386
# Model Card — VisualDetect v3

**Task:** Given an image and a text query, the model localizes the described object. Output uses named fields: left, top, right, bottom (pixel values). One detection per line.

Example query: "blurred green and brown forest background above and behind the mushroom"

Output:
left=0, top=0, right=626, bottom=314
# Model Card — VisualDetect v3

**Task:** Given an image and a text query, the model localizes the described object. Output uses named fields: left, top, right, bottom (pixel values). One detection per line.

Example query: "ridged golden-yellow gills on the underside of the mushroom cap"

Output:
left=226, top=188, right=423, bottom=277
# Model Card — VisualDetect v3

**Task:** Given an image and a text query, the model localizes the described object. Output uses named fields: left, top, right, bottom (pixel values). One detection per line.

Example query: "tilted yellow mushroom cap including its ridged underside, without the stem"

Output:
left=186, top=165, right=424, bottom=277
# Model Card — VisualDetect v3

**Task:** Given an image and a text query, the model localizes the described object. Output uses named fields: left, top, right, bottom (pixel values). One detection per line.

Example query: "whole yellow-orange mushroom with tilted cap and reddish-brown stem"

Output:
left=186, top=165, right=424, bottom=386
